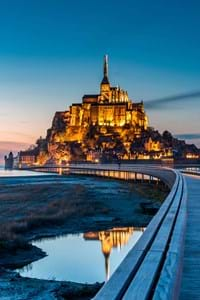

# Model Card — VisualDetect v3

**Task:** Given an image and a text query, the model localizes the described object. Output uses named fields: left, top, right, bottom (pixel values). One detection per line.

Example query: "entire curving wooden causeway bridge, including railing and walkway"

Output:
left=24, top=164, right=200, bottom=300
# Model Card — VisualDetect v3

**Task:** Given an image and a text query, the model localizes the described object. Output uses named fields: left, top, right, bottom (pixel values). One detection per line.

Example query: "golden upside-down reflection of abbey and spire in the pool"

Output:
left=83, top=227, right=144, bottom=280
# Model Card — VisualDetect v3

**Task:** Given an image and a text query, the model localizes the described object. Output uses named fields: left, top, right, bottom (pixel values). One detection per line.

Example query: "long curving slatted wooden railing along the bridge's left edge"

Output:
left=69, top=166, right=187, bottom=300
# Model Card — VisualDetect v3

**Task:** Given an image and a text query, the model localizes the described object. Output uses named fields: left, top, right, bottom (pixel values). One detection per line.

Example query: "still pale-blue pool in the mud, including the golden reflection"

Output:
left=16, top=228, right=144, bottom=283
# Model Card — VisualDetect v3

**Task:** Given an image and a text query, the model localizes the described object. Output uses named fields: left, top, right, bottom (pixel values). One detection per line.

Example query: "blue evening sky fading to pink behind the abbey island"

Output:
left=0, top=0, right=200, bottom=162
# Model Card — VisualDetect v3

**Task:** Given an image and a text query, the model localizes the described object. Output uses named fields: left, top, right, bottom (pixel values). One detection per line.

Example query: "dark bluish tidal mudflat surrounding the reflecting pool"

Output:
left=0, top=175, right=169, bottom=299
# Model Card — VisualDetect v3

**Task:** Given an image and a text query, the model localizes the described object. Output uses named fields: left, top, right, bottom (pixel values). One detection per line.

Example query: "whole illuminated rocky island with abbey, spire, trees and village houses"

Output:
left=18, top=56, right=199, bottom=166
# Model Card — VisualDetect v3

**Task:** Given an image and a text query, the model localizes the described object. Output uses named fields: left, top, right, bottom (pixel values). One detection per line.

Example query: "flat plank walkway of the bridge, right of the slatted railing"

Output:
left=180, top=175, right=200, bottom=300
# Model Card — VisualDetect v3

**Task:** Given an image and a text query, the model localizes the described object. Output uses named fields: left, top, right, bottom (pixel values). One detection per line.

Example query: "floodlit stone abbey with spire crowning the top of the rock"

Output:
left=70, top=56, right=148, bottom=133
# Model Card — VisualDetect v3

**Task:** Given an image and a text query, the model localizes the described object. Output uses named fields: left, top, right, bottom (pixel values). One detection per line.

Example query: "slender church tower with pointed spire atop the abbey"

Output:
left=100, top=55, right=110, bottom=101
